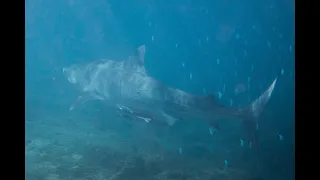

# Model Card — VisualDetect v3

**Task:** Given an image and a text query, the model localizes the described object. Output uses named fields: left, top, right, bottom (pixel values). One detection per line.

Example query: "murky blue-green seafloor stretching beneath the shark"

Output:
left=25, top=98, right=281, bottom=180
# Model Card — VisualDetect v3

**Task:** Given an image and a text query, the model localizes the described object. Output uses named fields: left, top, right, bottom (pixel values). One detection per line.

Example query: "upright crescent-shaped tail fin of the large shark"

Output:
left=242, top=71, right=281, bottom=150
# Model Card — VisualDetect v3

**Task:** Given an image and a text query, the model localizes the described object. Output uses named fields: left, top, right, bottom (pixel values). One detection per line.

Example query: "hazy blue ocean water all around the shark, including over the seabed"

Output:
left=25, top=0, right=295, bottom=180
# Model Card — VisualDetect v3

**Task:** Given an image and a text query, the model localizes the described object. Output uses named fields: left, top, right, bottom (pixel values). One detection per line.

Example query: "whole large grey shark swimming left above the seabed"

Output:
left=63, top=45, right=279, bottom=149
